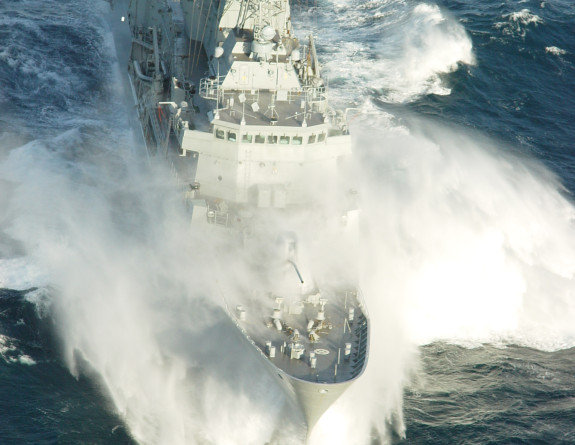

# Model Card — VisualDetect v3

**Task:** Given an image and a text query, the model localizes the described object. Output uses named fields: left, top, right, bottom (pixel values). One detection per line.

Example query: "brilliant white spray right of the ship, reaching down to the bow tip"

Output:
left=312, top=107, right=575, bottom=445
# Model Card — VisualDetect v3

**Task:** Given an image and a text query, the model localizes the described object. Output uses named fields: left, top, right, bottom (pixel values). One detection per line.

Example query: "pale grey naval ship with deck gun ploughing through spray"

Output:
left=118, top=0, right=369, bottom=434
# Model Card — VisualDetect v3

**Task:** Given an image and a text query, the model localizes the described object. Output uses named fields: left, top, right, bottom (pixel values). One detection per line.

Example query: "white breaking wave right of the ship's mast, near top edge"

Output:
left=296, top=0, right=475, bottom=103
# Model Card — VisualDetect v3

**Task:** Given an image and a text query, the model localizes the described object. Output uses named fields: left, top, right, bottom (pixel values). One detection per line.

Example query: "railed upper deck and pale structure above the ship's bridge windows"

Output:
left=181, top=26, right=327, bottom=129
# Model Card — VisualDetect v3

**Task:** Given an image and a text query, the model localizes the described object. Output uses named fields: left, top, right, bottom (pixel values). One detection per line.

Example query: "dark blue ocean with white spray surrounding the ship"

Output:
left=0, top=0, right=575, bottom=445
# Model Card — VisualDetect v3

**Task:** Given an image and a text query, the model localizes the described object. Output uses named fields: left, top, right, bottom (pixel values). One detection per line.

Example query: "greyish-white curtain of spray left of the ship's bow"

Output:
left=2, top=123, right=297, bottom=444
